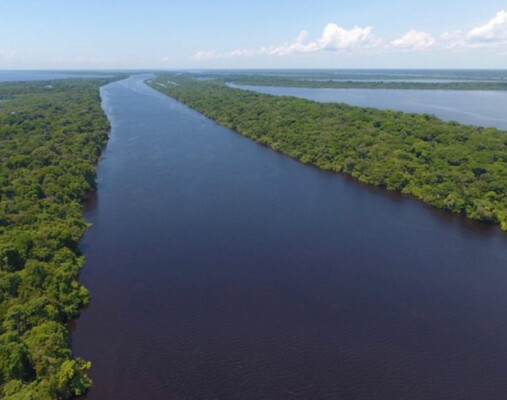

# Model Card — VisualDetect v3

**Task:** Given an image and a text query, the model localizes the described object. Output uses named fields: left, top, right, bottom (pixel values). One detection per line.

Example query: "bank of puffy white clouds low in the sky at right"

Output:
left=193, top=10, right=507, bottom=61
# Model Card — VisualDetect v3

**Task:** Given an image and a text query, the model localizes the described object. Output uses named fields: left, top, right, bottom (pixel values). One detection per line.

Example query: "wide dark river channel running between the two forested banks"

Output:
left=73, top=76, right=507, bottom=400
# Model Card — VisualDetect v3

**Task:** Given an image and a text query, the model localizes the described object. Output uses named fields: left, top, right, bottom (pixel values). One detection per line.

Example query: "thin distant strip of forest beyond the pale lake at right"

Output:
left=195, top=73, right=507, bottom=90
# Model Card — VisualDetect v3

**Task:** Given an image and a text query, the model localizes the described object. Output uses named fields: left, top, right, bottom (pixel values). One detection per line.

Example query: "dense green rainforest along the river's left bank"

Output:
left=0, top=78, right=118, bottom=400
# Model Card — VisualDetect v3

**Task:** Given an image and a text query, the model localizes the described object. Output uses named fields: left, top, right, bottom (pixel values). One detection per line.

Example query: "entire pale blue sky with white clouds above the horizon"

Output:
left=0, top=0, right=507, bottom=69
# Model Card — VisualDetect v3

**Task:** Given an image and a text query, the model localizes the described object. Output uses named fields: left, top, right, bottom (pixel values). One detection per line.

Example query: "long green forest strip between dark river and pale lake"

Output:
left=149, top=74, right=507, bottom=230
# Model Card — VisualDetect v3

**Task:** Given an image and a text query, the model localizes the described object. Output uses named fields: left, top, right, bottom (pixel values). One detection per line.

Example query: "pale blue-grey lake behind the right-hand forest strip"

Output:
left=230, top=84, right=507, bottom=130
